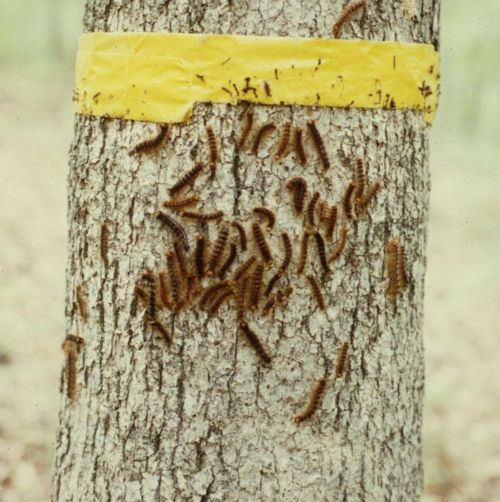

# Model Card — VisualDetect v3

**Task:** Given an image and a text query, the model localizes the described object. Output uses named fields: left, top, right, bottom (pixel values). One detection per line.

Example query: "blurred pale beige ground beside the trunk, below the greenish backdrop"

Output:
left=0, top=71, right=500, bottom=502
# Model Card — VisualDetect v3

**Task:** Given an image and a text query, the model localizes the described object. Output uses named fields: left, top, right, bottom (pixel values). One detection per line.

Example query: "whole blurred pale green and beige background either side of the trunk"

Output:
left=0, top=0, right=500, bottom=502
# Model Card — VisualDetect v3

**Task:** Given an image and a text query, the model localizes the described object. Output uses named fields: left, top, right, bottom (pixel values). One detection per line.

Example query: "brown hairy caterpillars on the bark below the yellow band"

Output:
left=63, top=109, right=406, bottom=424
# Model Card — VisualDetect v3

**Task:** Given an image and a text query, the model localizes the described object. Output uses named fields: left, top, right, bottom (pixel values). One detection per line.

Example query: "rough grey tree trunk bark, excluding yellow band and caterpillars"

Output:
left=53, top=0, right=439, bottom=501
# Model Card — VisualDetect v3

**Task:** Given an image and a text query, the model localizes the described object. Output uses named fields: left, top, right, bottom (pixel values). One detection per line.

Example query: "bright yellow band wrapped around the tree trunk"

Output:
left=75, top=33, right=439, bottom=123
